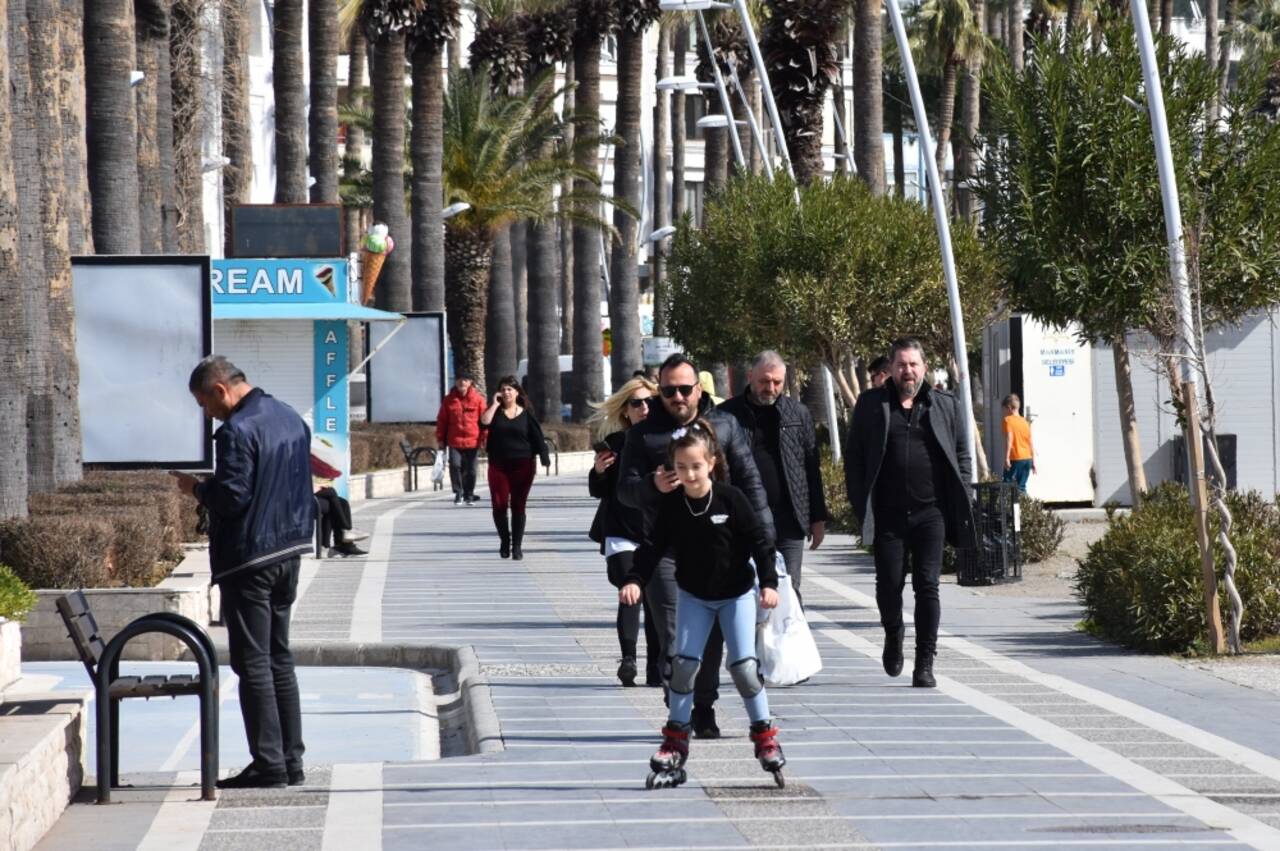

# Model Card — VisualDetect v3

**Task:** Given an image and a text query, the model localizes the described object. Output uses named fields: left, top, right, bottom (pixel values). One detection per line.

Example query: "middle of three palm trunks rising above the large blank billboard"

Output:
left=133, top=0, right=173, bottom=255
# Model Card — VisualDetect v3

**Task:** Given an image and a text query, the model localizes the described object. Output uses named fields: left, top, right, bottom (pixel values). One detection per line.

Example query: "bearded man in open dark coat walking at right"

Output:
left=845, top=338, right=977, bottom=688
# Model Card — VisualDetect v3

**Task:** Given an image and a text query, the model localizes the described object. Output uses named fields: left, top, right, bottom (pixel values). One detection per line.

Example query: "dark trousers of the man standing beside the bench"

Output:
left=220, top=557, right=306, bottom=774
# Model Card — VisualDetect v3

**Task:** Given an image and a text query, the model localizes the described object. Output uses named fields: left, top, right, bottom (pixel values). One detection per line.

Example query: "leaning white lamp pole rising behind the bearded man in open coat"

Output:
left=885, top=0, right=972, bottom=481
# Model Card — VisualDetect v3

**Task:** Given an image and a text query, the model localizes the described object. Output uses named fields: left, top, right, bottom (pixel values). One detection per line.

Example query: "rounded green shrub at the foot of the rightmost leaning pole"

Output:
left=1075, top=482, right=1280, bottom=653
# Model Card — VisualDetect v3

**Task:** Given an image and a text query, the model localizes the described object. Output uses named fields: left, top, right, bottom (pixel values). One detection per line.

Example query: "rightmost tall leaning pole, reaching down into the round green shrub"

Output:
left=1129, top=0, right=1226, bottom=653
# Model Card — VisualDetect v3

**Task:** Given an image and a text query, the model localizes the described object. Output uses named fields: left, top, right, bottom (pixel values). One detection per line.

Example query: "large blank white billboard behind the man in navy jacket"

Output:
left=72, top=256, right=212, bottom=470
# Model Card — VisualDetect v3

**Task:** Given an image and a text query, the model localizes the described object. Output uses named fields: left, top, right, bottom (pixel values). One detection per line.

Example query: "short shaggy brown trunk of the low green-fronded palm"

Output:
left=445, top=223, right=495, bottom=389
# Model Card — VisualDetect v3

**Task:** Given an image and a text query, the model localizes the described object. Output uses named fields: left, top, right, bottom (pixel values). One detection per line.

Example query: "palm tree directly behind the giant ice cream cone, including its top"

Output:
left=340, top=0, right=421, bottom=312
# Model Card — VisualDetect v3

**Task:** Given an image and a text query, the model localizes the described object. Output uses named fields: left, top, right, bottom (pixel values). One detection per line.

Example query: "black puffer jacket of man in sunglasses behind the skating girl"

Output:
left=617, top=394, right=774, bottom=545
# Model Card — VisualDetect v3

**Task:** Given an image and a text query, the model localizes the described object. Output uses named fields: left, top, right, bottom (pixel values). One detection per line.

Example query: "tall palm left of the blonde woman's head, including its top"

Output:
left=570, top=0, right=618, bottom=421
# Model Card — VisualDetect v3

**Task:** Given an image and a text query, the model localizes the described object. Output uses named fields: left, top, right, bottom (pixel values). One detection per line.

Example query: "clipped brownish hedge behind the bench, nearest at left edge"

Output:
left=0, top=516, right=114, bottom=589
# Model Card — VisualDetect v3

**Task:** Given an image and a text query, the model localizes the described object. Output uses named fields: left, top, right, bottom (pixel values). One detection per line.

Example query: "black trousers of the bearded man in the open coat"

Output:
left=876, top=505, right=946, bottom=655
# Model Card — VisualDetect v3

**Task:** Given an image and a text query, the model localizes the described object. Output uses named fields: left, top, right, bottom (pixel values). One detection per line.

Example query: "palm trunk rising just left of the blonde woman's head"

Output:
left=570, top=36, right=604, bottom=422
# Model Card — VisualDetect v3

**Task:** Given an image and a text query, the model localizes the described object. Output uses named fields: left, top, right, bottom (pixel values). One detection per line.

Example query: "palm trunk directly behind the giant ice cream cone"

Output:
left=372, top=32, right=412, bottom=314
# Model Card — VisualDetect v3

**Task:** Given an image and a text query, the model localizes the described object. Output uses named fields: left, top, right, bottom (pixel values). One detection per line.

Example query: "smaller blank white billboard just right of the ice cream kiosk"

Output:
left=369, top=311, right=447, bottom=422
